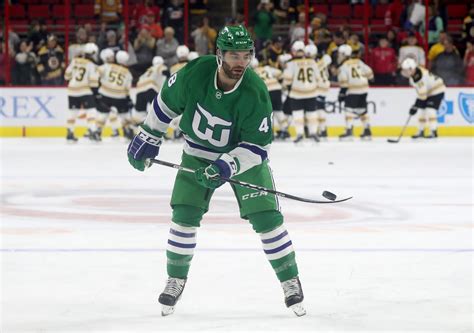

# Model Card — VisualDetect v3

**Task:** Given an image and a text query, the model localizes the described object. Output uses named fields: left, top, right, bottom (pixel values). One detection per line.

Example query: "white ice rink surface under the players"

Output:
left=0, top=138, right=474, bottom=333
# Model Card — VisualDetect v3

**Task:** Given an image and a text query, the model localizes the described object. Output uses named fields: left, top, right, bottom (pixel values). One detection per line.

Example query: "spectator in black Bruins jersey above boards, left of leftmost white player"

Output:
left=36, top=35, right=65, bottom=86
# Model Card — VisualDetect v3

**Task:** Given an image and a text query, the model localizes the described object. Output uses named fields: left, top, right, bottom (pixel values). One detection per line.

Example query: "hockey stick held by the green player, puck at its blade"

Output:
left=145, top=159, right=352, bottom=204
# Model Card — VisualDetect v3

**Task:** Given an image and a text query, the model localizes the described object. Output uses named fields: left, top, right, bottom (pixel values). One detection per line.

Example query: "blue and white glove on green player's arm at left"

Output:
left=127, top=125, right=163, bottom=171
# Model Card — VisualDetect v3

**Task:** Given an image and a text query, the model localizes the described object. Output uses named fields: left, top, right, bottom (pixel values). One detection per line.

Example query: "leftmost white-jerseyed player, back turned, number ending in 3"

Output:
left=64, top=43, right=99, bottom=142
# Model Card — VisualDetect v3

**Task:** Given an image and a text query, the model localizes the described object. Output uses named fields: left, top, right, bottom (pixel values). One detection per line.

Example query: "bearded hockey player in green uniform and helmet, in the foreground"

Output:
left=128, top=26, right=306, bottom=316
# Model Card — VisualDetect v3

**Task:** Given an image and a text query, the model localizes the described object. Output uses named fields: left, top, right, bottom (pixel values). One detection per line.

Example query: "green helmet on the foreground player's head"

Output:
left=216, top=25, right=254, bottom=51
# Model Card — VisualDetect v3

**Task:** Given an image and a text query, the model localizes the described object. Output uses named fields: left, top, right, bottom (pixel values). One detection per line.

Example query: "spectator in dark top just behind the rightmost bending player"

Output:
left=431, top=36, right=464, bottom=86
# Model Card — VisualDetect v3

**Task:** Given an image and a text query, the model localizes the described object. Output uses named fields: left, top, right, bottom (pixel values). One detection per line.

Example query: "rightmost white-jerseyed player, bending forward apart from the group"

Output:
left=402, top=58, right=446, bottom=139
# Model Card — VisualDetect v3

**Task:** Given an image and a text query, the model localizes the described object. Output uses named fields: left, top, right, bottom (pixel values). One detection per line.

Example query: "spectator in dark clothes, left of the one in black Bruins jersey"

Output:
left=12, top=40, right=38, bottom=86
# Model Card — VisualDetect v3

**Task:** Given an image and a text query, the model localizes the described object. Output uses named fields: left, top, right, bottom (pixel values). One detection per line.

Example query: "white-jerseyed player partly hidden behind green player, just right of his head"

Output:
left=251, top=58, right=286, bottom=139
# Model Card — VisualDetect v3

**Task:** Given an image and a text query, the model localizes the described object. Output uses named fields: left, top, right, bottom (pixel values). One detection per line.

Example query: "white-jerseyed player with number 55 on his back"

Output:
left=97, top=51, right=134, bottom=138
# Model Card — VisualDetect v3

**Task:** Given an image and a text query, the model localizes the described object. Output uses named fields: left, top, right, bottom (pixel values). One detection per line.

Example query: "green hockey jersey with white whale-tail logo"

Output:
left=145, top=56, right=273, bottom=174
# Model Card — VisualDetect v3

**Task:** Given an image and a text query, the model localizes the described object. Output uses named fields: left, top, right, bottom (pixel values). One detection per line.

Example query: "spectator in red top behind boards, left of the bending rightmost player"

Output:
left=370, top=37, right=397, bottom=86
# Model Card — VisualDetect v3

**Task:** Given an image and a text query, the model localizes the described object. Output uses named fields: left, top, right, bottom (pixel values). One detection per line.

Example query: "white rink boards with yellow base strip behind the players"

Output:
left=0, top=87, right=474, bottom=137
